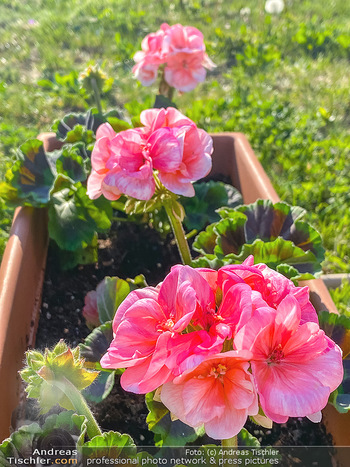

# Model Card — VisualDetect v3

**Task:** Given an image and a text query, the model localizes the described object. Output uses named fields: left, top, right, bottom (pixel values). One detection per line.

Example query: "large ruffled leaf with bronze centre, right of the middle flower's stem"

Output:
left=193, top=200, right=324, bottom=281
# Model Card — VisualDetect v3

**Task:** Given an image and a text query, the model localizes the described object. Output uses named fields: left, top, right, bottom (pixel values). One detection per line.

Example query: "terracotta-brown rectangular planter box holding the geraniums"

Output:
left=0, top=133, right=350, bottom=458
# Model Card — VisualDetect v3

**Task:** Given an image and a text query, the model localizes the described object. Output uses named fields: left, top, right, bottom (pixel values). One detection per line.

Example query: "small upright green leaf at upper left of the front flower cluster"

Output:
left=96, top=276, right=130, bottom=323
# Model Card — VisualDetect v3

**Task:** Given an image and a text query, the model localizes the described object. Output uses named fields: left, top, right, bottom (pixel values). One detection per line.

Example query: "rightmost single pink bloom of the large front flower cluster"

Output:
left=234, top=295, right=343, bottom=423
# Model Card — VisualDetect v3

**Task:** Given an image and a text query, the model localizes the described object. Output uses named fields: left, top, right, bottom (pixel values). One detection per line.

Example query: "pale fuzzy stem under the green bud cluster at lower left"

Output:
left=51, top=378, right=102, bottom=439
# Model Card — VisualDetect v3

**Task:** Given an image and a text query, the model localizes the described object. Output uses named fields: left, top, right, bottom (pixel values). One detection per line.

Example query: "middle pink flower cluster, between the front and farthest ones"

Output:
left=87, top=107, right=213, bottom=200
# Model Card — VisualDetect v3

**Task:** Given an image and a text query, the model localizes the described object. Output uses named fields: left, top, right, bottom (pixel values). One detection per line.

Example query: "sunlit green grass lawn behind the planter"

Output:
left=0, top=0, right=350, bottom=272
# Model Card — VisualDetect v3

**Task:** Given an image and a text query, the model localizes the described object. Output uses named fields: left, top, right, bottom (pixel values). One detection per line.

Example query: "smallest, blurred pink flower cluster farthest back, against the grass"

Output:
left=132, top=23, right=215, bottom=92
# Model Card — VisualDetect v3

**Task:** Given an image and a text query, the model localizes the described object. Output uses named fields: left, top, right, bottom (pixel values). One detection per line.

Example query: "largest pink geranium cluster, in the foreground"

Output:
left=101, top=257, right=343, bottom=439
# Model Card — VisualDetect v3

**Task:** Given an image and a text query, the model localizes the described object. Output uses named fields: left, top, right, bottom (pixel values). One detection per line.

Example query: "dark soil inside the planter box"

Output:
left=30, top=218, right=332, bottom=465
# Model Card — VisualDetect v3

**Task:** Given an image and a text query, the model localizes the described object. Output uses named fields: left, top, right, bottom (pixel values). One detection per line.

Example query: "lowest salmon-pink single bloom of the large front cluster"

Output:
left=161, top=351, right=258, bottom=439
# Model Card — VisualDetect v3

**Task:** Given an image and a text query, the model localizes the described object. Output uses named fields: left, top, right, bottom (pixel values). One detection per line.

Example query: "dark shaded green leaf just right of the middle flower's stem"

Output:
left=181, top=180, right=242, bottom=234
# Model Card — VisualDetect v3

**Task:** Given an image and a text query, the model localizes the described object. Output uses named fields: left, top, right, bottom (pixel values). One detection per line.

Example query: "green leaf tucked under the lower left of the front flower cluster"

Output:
left=146, top=392, right=204, bottom=446
